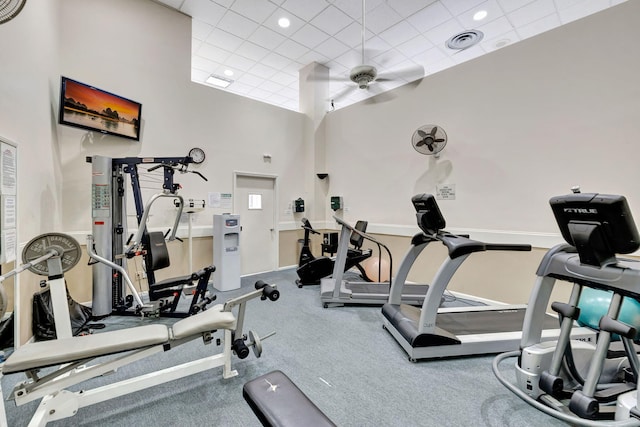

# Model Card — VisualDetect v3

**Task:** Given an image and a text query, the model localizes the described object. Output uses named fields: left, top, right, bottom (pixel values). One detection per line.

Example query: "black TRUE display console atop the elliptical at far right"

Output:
left=549, top=193, right=640, bottom=266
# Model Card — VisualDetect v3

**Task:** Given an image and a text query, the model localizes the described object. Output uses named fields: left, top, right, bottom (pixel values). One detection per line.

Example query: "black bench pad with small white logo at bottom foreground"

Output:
left=242, top=370, right=335, bottom=427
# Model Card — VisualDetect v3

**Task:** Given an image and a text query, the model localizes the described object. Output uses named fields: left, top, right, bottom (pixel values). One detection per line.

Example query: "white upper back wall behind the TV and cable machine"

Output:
left=52, top=0, right=304, bottom=231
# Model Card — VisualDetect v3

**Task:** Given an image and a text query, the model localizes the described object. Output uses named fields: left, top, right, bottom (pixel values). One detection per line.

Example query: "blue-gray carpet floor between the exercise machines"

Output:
left=2, top=269, right=564, bottom=427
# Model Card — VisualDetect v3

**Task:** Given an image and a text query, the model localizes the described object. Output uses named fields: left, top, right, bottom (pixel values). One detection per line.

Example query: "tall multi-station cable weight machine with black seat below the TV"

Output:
left=86, top=156, right=208, bottom=318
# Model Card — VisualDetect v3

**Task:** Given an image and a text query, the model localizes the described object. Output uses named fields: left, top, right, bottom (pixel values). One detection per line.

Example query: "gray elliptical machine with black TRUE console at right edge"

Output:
left=493, top=189, right=640, bottom=426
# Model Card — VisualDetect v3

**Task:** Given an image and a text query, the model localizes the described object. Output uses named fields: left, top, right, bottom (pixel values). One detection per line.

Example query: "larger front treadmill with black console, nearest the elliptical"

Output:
left=382, top=194, right=595, bottom=362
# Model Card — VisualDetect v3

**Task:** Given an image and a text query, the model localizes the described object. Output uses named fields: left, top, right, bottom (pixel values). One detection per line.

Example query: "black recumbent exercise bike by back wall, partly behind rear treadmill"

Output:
left=296, top=218, right=372, bottom=288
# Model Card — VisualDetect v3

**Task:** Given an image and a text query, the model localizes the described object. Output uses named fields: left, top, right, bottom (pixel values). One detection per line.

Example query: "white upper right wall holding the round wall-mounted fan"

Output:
left=326, top=2, right=640, bottom=233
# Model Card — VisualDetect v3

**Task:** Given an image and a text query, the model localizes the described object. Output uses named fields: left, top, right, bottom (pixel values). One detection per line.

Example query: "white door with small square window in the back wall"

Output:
left=234, top=173, right=278, bottom=275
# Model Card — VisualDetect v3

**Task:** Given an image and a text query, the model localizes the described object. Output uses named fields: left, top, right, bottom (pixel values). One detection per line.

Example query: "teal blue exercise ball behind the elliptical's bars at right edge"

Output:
left=578, top=287, right=640, bottom=339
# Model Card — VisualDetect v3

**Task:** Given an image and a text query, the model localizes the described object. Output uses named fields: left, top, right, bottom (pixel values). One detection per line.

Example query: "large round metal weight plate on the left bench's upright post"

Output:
left=22, top=233, right=82, bottom=276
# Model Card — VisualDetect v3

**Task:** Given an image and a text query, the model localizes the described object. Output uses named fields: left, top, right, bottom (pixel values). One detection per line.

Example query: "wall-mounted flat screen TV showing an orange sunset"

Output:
left=59, top=76, right=142, bottom=141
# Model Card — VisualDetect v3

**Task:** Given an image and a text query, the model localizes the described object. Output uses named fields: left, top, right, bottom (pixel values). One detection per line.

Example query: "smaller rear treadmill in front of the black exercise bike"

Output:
left=320, top=216, right=429, bottom=308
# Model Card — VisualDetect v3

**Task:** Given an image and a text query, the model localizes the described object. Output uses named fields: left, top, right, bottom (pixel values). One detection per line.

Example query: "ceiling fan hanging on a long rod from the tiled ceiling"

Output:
left=322, top=0, right=424, bottom=103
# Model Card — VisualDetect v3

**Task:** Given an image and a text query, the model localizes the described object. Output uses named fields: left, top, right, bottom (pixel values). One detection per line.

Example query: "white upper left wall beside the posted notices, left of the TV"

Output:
left=0, top=0, right=62, bottom=241
